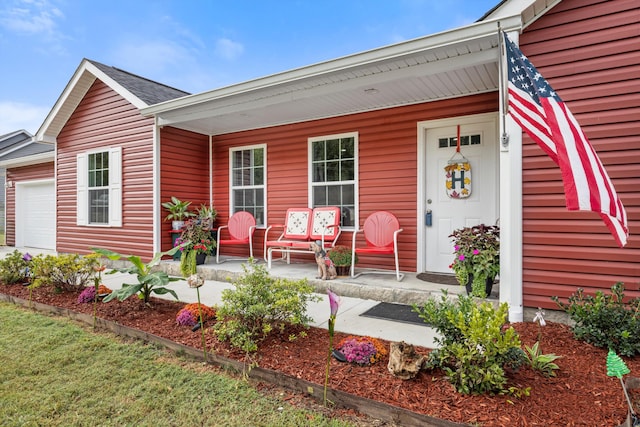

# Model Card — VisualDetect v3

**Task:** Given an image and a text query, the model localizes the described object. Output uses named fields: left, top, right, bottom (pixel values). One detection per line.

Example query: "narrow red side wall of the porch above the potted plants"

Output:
left=160, top=127, right=210, bottom=251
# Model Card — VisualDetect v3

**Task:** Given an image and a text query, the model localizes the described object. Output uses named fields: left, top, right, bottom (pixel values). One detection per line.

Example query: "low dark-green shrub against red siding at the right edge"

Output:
left=551, top=282, right=640, bottom=357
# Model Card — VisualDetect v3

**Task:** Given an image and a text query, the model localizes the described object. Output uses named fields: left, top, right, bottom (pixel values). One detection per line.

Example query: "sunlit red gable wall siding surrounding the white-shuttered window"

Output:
left=56, top=80, right=158, bottom=258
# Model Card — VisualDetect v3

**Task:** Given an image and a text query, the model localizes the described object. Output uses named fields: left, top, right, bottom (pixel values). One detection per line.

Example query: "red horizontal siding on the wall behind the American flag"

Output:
left=520, top=0, right=640, bottom=308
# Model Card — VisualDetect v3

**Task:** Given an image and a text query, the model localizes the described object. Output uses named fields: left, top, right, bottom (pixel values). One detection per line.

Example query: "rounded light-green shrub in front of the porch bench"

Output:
left=214, top=260, right=320, bottom=353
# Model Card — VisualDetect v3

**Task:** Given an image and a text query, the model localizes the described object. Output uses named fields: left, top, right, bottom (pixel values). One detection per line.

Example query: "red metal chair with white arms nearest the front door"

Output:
left=351, top=211, right=404, bottom=282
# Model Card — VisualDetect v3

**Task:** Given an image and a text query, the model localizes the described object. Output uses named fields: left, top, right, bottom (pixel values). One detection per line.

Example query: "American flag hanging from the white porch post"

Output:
left=504, top=34, right=629, bottom=247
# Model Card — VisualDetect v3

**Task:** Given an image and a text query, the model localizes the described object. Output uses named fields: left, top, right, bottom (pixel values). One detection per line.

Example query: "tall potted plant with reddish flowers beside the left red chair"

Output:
left=174, top=218, right=216, bottom=277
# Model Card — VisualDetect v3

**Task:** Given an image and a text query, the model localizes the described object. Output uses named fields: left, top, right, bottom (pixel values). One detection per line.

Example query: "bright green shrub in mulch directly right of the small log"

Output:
left=414, top=293, right=522, bottom=394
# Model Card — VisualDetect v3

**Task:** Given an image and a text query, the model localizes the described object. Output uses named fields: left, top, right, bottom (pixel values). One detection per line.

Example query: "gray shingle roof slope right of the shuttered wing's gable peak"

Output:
left=89, top=60, right=190, bottom=105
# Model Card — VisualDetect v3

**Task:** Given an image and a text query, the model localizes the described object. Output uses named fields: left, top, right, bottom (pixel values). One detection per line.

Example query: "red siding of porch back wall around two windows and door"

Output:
left=208, top=93, right=498, bottom=271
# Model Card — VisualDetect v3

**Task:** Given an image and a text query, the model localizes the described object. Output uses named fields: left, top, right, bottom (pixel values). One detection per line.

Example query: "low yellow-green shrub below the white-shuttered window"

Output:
left=31, top=254, right=99, bottom=292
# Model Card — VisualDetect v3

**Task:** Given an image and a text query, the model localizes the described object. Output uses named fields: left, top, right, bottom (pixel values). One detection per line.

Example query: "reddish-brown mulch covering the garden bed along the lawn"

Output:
left=0, top=285, right=640, bottom=427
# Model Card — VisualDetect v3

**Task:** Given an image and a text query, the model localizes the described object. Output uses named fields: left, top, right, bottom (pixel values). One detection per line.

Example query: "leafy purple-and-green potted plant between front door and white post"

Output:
left=449, top=224, right=500, bottom=298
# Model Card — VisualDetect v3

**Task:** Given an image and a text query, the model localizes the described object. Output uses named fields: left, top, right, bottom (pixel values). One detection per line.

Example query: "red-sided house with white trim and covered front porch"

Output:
left=8, top=0, right=640, bottom=320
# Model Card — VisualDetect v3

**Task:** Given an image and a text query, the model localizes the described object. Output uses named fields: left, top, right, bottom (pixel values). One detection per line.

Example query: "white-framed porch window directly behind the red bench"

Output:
left=309, top=134, right=357, bottom=227
